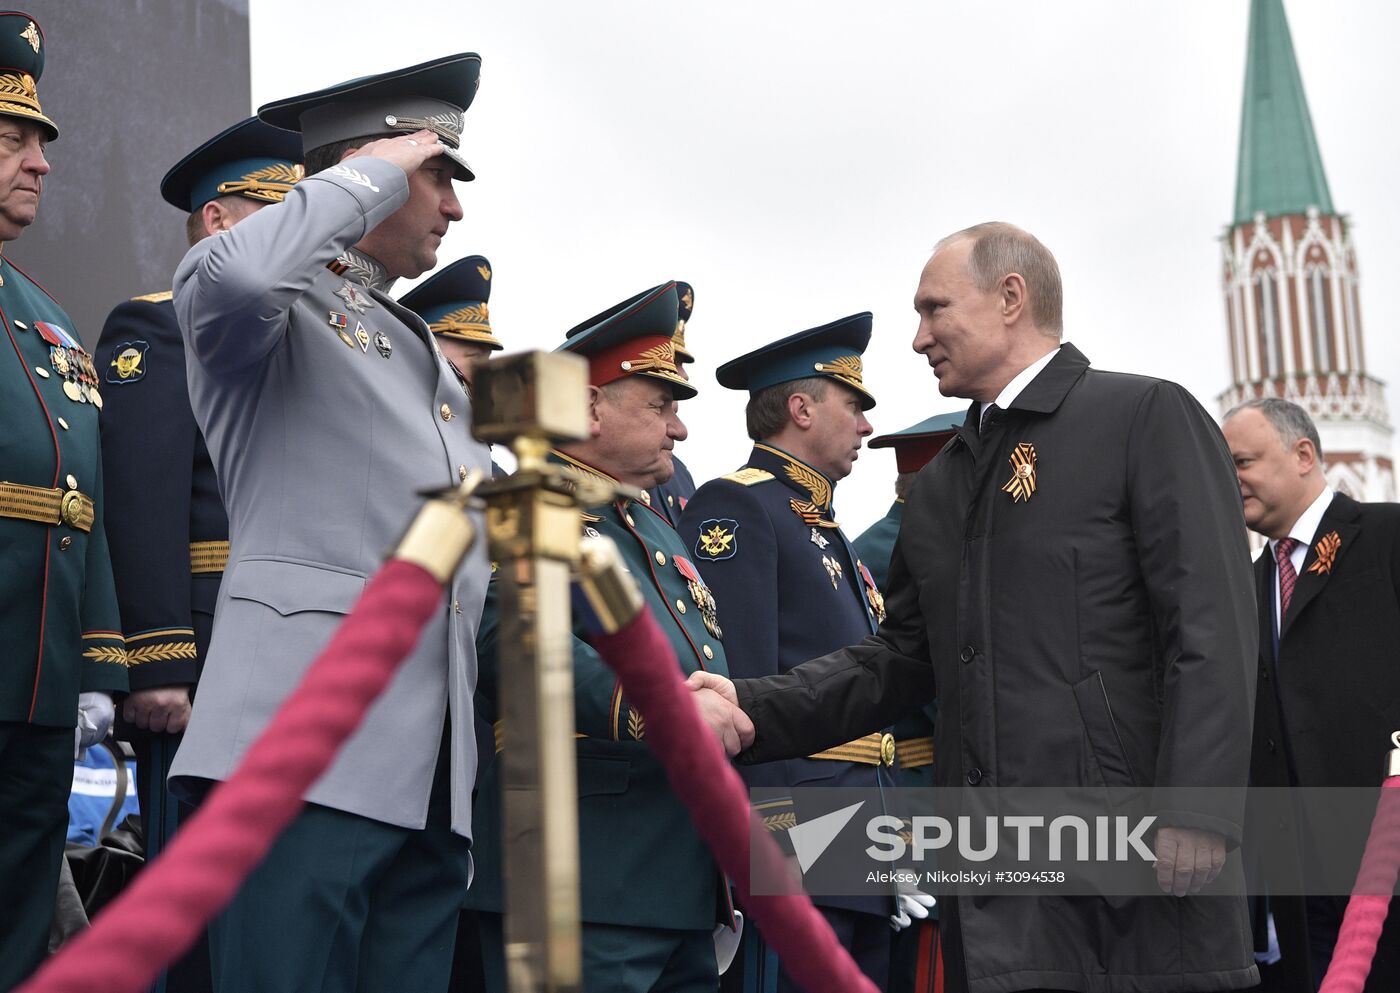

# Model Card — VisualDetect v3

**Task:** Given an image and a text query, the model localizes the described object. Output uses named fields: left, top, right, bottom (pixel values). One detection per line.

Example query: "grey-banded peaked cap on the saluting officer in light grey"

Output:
left=258, top=52, right=482, bottom=181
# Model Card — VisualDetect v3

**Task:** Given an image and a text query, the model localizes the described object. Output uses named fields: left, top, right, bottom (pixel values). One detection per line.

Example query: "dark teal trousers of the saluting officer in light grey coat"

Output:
left=209, top=748, right=472, bottom=993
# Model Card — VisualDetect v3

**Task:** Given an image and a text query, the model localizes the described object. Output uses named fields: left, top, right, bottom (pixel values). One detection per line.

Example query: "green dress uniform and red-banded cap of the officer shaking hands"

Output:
left=466, top=284, right=732, bottom=993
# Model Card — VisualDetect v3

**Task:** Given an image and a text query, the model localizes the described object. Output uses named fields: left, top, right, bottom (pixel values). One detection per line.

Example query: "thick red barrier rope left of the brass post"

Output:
left=17, top=560, right=442, bottom=993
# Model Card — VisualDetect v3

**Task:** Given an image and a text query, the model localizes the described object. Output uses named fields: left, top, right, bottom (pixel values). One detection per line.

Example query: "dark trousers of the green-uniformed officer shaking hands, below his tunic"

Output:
left=480, top=913, right=720, bottom=993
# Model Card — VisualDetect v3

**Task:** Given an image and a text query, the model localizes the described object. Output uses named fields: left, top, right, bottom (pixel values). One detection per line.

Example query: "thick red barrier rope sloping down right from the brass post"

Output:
left=594, top=609, right=876, bottom=993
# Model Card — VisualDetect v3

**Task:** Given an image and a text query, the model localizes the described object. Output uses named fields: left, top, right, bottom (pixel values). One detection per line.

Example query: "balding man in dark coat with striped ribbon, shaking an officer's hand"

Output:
left=690, top=224, right=1259, bottom=993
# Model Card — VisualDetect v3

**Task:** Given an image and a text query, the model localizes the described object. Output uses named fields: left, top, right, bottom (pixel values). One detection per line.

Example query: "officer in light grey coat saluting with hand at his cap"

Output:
left=171, top=53, right=490, bottom=992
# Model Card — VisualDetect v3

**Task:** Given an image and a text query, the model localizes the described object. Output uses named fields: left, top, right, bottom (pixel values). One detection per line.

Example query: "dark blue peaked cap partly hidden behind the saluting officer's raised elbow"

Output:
left=161, top=118, right=302, bottom=213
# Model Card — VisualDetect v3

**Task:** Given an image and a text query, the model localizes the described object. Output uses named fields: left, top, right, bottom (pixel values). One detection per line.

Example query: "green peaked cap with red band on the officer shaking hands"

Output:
left=554, top=282, right=696, bottom=401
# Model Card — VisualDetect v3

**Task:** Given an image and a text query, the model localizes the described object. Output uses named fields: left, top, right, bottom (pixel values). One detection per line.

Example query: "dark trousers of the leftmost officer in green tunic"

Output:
left=0, top=722, right=77, bottom=990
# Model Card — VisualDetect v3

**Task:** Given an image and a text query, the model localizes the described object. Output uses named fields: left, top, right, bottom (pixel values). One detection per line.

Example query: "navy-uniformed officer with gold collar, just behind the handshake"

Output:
left=679, top=314, right=896, bottom=990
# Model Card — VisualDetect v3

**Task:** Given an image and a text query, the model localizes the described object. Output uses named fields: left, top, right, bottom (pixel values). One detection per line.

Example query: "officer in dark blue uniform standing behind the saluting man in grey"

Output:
left=97, top=118, right=301, bottom=993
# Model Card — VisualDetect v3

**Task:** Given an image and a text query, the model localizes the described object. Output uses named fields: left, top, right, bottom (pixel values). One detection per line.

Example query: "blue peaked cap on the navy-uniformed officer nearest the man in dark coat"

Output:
left=715, top=311, right=875, bottom=410
